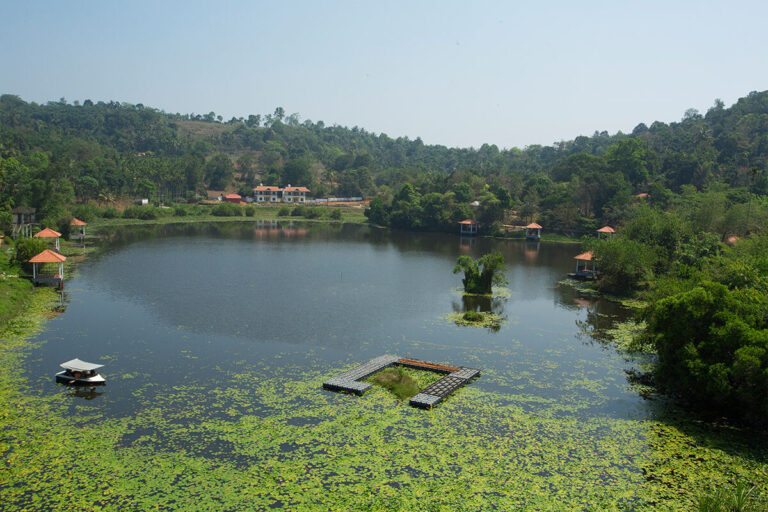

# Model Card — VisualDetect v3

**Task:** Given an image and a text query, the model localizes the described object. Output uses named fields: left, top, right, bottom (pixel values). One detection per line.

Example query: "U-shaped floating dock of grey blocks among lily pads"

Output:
left=323, top=355, right=480, bottom=409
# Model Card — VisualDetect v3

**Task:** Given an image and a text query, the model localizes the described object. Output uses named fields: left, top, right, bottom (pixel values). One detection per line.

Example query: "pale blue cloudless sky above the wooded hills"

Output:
left=0, top=0, right=768, bottom=148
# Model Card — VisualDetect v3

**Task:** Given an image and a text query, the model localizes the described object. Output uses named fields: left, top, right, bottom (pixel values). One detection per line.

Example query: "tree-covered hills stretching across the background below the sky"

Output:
left=0, top=91, right=768, bottom=231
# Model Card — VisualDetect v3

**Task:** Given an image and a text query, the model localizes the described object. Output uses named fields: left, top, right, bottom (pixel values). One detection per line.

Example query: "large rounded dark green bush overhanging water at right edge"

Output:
left=648, top=282, right=768, bottom=424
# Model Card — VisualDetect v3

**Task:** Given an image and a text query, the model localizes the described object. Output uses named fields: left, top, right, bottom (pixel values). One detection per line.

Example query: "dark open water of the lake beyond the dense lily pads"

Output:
left=27, top=222, right=650, bottom=419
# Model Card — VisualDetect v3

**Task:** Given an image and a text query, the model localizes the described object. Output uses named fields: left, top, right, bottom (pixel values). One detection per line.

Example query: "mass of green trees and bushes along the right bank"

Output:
left=589, top=202, right=768, bottom=425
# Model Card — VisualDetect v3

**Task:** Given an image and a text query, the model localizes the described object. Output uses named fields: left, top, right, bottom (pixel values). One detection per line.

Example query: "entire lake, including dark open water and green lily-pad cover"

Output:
left=0, top=221, right=765, bottom=510
